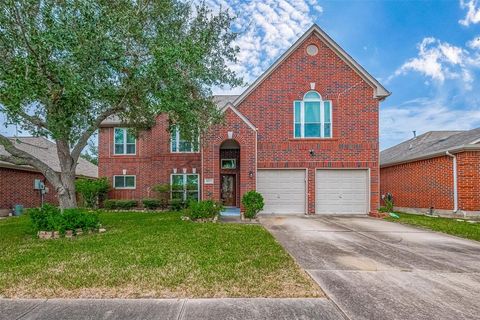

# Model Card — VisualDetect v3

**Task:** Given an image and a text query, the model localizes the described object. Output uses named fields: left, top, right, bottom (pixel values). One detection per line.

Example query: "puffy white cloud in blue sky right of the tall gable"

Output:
left=389, top=37, right=480, bottom=90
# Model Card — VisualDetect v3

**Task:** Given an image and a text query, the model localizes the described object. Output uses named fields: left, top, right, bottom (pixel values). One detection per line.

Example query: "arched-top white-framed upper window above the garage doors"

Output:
left=293, top=91, right=332, bottom=138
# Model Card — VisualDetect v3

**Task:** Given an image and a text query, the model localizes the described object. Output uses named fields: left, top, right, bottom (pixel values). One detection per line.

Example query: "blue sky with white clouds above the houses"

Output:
left=0, top=0, right=480, bottom=149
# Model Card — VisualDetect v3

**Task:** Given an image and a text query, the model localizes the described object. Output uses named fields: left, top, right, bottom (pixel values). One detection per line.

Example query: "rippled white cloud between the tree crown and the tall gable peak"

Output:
left=207, top=0, right=323, bottom=93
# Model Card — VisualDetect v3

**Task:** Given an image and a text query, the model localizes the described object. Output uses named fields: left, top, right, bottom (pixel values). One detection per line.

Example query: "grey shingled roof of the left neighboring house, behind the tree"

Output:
left=0, top=137, right=98, bottom=178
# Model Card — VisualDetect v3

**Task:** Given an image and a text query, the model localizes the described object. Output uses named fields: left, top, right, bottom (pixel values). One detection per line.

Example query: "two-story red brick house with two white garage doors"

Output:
left=99, top=25, right=390, bottom=214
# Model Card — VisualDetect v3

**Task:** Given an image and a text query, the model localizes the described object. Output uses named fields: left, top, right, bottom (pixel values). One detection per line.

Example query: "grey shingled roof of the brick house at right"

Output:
left=380, top=128, right=480, bottom=167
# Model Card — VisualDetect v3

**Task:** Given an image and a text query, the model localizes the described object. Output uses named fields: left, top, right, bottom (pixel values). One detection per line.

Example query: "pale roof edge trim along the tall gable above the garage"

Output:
left=233, top=24, right=391, bottom=106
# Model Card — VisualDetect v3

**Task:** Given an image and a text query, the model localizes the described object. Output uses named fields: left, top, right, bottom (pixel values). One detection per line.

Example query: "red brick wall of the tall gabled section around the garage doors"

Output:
left=238, top=36, right=379, bottom=213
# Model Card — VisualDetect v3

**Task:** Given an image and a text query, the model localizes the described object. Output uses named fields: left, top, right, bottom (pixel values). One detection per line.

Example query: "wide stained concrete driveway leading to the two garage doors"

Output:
left=261, top=216, right=480, bottom=320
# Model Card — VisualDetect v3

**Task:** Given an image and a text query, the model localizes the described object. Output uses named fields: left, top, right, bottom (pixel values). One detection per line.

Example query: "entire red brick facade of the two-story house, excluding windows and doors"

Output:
left=99, top=32, right=379, bottom=213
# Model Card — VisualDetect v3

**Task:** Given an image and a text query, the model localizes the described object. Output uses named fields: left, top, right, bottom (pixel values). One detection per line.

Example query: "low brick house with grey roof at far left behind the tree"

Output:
left=0, top=137, right=98, bottom=216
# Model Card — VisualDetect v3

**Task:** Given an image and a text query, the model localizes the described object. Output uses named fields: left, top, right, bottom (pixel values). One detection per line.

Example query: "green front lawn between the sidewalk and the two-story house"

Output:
left=0, top=212, right=323, bottom=298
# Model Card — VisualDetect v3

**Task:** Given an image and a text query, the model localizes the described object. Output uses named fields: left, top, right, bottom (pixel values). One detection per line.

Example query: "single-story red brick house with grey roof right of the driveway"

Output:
left=380, top=128, right=480, bottom=214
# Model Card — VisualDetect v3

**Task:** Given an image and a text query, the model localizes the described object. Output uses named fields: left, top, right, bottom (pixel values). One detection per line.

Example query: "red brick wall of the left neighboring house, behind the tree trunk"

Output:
left=0, top=168, right=58, bottom=209
